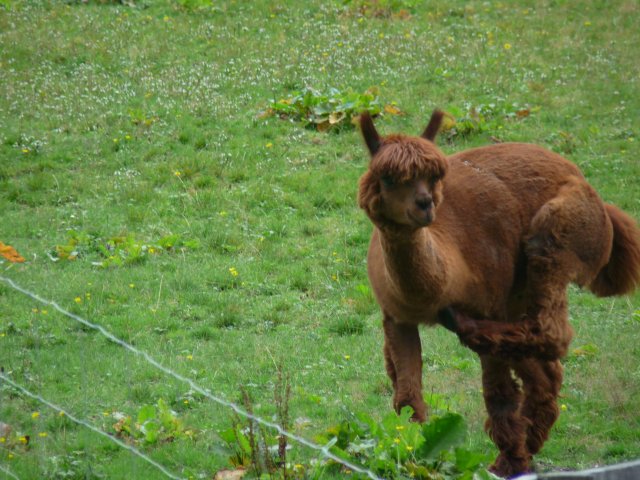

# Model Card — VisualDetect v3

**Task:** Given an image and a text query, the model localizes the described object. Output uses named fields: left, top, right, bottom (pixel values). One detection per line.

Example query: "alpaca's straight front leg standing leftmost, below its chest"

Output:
left=383, top=315, right=427, bottom=422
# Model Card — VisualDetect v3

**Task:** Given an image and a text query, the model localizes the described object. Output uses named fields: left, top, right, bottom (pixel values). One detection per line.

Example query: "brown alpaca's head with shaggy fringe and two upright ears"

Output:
left=358, top=110, right=447, bottom=229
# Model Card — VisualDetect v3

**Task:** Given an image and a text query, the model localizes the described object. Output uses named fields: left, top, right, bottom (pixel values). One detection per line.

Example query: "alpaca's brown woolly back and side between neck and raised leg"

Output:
left=430, top=143, right=603, bottom=318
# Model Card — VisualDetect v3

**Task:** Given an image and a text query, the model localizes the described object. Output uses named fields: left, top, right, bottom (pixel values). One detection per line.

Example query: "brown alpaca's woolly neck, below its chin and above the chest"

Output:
left=380, top=228, right=447, bottom=299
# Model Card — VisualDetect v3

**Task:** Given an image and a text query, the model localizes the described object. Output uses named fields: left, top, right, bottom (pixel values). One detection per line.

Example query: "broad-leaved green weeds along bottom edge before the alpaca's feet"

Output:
left=220, top=392, right=496, bottom=480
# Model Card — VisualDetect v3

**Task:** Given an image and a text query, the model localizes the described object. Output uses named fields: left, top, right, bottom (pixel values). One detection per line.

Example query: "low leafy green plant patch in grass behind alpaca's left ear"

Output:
left=260, top=87, right=401, bottom=132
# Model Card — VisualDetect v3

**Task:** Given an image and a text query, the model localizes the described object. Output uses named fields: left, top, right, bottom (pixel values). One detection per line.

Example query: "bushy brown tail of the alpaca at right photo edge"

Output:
left=589, top=204, right=640, bottom=297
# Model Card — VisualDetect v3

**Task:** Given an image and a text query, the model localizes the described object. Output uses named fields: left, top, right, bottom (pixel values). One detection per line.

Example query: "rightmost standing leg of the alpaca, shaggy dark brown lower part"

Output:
left=514, top=358, right=563, bottom=455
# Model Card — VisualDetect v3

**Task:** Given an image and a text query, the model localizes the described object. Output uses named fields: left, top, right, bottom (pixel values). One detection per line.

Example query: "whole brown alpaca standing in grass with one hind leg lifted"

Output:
left=358, top=110, right=640, bottom=477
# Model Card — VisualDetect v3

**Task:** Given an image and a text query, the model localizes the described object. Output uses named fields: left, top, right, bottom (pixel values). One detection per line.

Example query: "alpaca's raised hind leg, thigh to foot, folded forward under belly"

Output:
left=438, top=186, right=600, bottom=360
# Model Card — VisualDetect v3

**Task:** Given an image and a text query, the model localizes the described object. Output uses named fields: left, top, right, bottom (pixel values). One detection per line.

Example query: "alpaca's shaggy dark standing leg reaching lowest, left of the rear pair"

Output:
left=480, top=356, right=530, bottom=477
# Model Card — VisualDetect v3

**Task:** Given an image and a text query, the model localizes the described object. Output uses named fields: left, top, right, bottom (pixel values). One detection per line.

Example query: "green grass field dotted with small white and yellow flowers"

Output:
left=0, top=0, right=640, bottom=479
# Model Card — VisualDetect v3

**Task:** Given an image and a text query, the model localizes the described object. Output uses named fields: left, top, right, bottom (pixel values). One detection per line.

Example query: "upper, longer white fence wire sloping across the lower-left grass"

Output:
left=0, top=275, right=382, bottom=480
